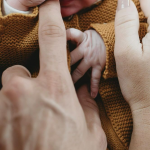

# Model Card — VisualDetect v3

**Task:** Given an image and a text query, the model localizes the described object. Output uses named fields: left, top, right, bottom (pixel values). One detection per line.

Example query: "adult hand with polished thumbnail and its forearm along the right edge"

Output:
left=115, top=0, right=150, bottom=150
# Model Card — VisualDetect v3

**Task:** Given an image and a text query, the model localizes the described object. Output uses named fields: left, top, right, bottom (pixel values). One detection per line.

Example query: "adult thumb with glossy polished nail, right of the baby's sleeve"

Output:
left=114, top=0, right=141, bottom=57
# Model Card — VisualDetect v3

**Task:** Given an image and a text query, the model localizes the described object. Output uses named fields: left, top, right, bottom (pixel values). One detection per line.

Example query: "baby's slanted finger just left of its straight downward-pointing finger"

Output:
left=72, top=59, right=91, bottom=83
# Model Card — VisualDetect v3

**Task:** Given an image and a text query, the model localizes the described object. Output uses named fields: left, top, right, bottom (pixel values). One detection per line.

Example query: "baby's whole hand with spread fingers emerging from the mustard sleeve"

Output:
left=67, top=28, right=106, bottom=98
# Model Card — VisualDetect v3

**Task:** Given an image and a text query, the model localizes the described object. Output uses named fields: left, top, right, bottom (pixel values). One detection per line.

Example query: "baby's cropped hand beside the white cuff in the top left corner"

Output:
left=6, top=0, right=45, bottom=11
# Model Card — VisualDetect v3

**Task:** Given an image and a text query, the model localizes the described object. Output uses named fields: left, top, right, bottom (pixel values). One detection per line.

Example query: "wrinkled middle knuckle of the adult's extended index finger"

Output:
left=40, top=24, right=66, bottom=38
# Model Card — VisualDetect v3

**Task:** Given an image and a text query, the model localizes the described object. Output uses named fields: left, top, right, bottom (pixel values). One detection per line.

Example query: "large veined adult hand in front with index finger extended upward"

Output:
left=0, top=0, right=107, bottom=150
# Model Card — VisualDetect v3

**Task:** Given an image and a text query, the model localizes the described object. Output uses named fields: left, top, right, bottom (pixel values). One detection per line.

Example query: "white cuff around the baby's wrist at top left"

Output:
left=2, top=0, right=32, bottom=16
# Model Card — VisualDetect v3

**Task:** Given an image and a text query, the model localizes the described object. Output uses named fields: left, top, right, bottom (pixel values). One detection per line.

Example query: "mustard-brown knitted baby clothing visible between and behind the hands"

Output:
left=0, top=0, right=148, bottom=150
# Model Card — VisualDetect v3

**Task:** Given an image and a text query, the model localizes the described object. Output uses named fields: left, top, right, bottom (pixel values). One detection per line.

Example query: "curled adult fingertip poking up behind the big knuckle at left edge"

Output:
left=2, top=65, right=31, bottom=86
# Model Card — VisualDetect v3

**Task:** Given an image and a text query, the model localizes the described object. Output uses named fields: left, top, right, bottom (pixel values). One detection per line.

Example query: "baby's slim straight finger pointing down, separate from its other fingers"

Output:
left=91, top=66, right=101, bottom=98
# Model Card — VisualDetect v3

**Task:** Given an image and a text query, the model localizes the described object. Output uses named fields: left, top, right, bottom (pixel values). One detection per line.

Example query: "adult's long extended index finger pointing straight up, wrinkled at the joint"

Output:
left=39, top=0, right=68, bottom=74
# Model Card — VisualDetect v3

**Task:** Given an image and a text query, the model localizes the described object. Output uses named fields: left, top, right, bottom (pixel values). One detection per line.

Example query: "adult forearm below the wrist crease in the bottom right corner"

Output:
left=129, top=108, right=150, bottom=150
